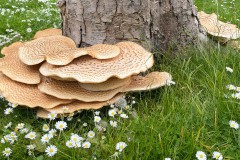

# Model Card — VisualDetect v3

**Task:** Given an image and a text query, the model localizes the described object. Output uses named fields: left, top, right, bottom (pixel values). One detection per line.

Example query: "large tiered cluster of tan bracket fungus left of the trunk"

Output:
left=0, top=29, right=171, bottom=118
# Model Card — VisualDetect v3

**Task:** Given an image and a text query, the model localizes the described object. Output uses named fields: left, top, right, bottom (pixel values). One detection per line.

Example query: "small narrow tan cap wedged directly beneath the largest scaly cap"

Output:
left=79, top=77, right=131, bottom=91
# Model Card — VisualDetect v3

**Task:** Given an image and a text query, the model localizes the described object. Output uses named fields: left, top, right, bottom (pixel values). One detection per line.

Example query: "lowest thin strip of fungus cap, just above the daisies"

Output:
left=37, top=94, right=123, bottom=118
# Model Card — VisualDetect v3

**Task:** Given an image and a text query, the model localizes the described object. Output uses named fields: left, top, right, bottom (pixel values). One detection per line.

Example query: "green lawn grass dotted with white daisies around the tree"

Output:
left=0, top=0, right=240, bottom=160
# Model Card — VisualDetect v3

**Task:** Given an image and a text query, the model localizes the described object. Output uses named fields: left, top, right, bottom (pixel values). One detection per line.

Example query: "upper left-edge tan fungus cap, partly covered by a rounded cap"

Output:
left=0, top=42, right=41, bottom=84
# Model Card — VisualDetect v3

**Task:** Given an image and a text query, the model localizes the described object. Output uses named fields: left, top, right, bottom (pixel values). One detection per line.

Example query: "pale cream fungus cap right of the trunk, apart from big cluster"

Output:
left=198, top=12, right=240, bottom=42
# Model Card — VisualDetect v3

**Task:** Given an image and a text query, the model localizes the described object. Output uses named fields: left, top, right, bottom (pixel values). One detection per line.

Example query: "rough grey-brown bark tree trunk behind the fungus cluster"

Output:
left=58, top=0, right=204, bottom=50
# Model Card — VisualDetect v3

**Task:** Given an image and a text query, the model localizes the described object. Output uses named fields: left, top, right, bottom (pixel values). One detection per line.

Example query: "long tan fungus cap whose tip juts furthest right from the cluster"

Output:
left=38, top=72, right=171, bottom=102
